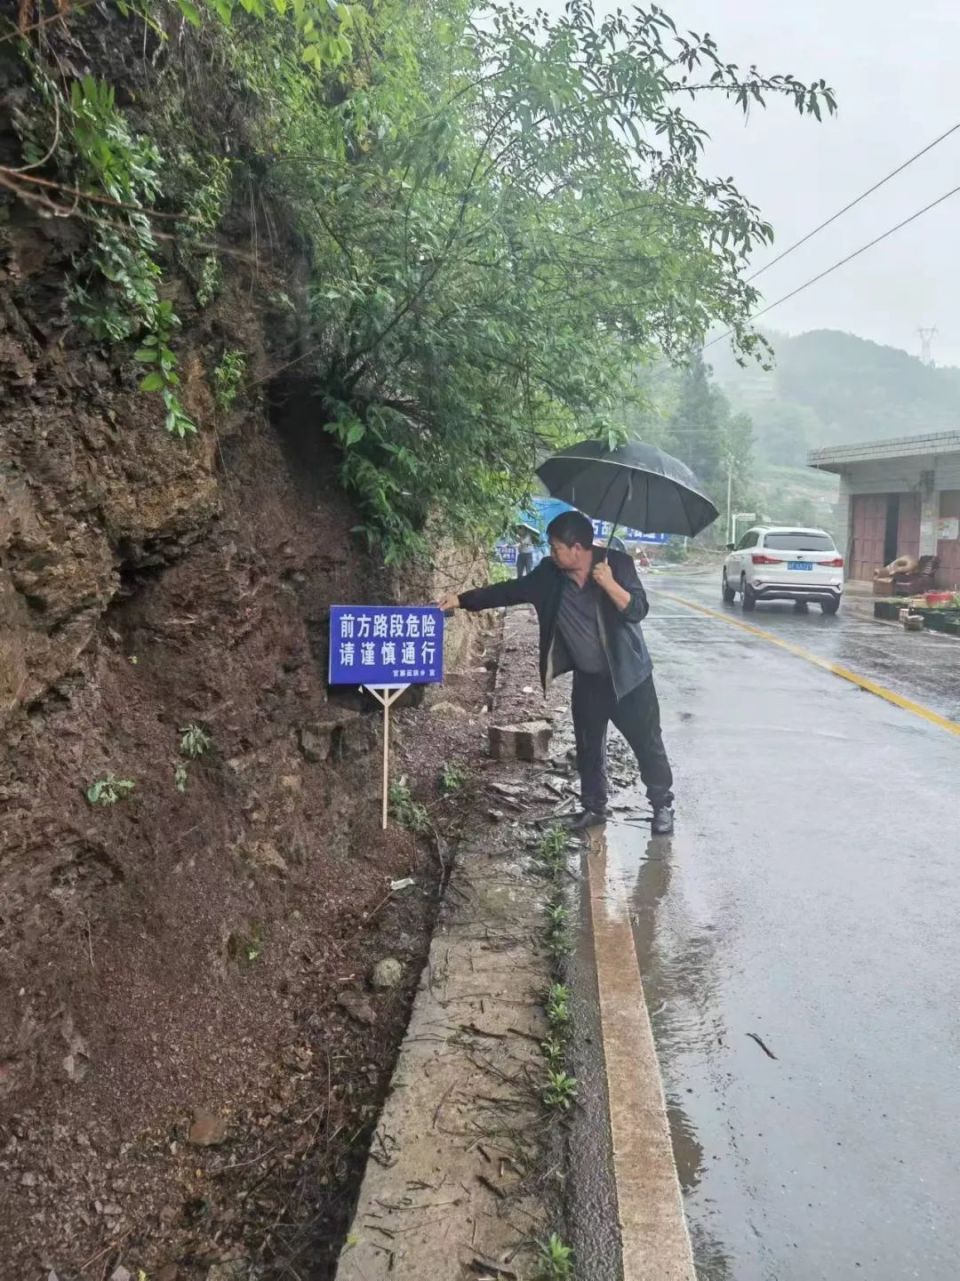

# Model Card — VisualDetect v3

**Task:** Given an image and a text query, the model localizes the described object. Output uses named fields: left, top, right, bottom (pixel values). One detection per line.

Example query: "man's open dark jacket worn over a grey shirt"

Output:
left=460, top=548, right=652, bottom=699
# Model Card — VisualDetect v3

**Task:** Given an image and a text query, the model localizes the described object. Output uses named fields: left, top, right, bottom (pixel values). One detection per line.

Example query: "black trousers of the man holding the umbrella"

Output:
left=573, top=671, right=673, bottom=813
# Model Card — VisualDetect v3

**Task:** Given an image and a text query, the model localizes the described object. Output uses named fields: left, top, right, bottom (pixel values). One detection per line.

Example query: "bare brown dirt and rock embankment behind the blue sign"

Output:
left=0, top=49, right=502, bottom=1281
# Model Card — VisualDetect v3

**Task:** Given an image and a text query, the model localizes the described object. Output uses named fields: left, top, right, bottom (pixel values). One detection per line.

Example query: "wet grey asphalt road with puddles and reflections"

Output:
left=608, top=574, right=960, bottom=1281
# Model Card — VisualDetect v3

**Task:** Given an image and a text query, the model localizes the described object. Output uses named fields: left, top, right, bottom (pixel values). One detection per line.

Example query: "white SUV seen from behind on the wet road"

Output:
left=723, top=525, right=843, bottom=614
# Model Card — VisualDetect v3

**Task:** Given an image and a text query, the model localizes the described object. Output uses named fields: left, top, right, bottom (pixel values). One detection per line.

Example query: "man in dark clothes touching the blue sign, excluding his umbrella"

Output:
left=440, top=511, right=673, bottom=836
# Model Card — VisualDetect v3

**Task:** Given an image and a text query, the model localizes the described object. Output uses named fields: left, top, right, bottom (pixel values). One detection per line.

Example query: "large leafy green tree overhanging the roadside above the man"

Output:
left=279, top=3, right=832, bottom=556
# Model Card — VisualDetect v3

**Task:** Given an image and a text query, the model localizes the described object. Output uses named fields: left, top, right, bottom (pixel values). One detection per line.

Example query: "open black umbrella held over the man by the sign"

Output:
left=537, top=441, right=719, bottom=537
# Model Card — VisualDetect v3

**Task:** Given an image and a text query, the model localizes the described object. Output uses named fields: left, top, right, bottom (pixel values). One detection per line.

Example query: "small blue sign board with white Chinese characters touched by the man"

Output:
left=329, top=605, right=443, bottom=689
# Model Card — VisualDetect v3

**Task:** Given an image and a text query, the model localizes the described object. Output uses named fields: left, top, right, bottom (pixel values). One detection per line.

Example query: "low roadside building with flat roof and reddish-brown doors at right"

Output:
left=807, top=432, right=960, bottom=589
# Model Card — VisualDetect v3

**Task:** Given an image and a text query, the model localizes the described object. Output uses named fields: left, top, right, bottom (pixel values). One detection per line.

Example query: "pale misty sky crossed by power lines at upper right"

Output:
left=531, top=0, right=960, bottom=365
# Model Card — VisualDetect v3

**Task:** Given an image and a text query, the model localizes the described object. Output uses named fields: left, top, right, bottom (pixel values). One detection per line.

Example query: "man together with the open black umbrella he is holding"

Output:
left=442, top=441, right=718, bottom=836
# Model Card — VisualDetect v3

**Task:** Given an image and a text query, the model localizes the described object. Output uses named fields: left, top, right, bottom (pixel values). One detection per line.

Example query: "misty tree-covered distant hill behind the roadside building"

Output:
left=714, top=329, right=960, bottom=466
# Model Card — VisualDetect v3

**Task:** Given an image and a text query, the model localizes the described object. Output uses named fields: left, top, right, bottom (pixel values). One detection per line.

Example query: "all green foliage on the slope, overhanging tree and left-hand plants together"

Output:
left=3, top=0, right=833, bottom=561
